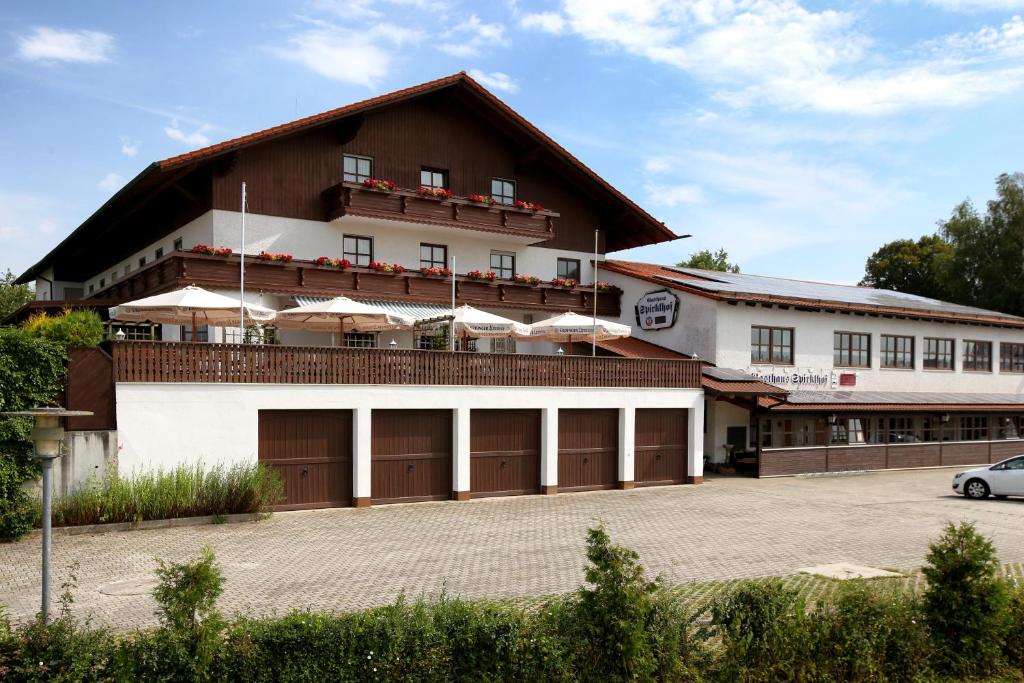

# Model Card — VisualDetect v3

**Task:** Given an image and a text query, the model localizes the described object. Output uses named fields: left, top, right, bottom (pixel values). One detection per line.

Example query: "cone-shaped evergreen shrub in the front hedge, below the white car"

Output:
left=923, top=522, right=1009, bottom=676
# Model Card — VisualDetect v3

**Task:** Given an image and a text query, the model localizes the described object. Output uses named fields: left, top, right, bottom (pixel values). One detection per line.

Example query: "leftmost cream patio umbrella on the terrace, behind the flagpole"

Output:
left=110, top=285, right=276, bottom=339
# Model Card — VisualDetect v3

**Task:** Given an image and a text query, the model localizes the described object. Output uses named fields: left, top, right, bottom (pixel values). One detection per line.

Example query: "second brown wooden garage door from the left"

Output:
left=370, top=411, right=452, bottom=503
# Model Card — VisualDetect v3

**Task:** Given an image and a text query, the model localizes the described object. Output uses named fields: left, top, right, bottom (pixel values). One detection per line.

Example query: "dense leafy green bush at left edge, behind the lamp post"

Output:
left=0, top=328, right=68, bottom=542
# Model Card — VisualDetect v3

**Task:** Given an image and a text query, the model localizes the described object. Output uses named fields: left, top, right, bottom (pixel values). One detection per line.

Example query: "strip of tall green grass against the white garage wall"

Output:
left=52, top=464, right=284, bottom=526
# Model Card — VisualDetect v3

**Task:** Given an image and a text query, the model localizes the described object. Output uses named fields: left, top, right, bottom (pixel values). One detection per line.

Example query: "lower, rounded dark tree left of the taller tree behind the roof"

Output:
left=860, top=234, right=953, bottom=300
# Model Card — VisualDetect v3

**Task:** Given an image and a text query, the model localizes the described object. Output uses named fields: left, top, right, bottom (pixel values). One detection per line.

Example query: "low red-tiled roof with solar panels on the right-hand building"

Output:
left=602, top=260, right=1024, bottom=328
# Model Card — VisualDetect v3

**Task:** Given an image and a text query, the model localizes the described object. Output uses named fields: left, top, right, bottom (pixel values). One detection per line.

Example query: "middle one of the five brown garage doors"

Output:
left=469, top=410, right=541, bottom=498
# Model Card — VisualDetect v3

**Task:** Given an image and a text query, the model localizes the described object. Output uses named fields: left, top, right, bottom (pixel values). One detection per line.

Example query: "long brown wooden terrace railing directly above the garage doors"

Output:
left=113, top=342, right=700, bottom=389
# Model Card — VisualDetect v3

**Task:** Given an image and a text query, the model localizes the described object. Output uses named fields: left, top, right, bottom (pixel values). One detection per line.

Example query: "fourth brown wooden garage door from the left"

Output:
left=558, top=410, right=618, bottom=492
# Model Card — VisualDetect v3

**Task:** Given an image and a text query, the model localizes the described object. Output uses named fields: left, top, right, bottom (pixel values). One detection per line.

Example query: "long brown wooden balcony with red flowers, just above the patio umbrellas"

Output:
left=92, top=252, right=621, bottom=317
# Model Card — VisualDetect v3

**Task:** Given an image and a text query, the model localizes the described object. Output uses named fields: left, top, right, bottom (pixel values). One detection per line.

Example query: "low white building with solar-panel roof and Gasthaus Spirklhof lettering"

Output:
left=602, top=260, right=1024, bottom=476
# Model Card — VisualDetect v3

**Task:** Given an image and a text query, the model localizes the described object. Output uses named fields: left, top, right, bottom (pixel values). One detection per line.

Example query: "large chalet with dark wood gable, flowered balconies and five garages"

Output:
left=9, top=74, right=703, bottom=507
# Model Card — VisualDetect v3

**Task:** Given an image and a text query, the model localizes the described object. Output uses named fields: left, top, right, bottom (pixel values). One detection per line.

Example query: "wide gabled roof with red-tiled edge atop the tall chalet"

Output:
left=17, top=72, right=677, bottom=283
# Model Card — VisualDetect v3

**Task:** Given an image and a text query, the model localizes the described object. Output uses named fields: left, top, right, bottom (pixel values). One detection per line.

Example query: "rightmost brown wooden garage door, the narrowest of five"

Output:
left=634, top=409, right=687, bottom=485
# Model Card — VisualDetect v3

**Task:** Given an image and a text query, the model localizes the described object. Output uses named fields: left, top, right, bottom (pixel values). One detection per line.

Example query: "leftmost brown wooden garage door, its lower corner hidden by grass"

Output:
left=258, top=411, right=352, bottom=510
